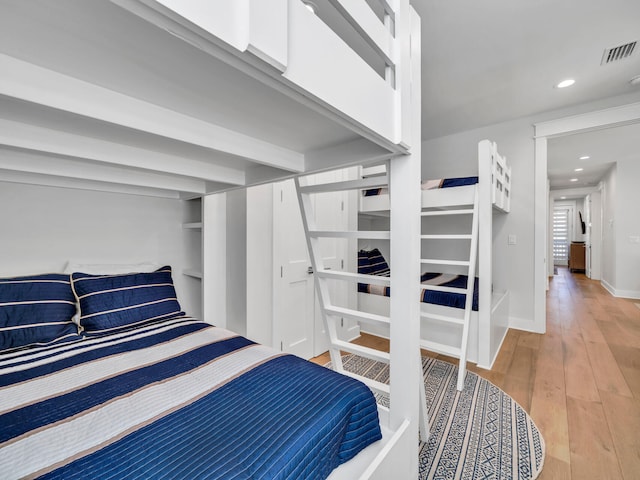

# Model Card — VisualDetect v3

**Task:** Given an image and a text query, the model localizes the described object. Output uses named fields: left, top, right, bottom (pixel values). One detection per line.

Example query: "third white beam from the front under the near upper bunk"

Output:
left=0, top=149, right=206, bottom=194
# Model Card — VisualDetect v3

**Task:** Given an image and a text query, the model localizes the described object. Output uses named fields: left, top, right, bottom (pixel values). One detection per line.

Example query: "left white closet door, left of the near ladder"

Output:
left=273, top=180, right=315, bottom=359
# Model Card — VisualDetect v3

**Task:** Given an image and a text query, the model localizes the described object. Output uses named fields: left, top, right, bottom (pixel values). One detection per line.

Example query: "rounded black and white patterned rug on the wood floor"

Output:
left=332, top=355, right=544, bottom=480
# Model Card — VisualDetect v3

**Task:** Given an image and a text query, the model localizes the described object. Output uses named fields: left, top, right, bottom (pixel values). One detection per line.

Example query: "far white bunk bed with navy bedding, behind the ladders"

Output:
left=358, top=140, right=511, bottom=368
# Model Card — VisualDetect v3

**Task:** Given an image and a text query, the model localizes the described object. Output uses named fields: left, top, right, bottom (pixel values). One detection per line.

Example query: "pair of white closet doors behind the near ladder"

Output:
left=273, top=171, right=359, bottom=358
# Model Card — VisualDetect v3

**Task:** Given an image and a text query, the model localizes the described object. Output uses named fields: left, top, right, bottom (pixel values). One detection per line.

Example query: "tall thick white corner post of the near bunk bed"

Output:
left=389, top=3, right=424, bottom=478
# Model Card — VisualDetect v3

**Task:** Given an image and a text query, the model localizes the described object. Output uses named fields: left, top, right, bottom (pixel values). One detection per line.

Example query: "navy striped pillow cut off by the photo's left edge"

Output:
left=0, top=273, right=80, bottom=352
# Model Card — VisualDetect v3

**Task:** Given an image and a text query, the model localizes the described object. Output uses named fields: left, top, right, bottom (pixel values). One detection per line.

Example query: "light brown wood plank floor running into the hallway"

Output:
left=314, top=268, right=640, bottom=480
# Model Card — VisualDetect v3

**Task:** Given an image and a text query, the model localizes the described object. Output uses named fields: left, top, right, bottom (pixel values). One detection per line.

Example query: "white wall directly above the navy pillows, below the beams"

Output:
left=0, top=182, right=199, bottom=313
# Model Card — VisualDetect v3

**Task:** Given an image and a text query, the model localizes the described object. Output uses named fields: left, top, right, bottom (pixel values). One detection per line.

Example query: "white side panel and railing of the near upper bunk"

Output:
left=111, top=0, right=411, bottom=153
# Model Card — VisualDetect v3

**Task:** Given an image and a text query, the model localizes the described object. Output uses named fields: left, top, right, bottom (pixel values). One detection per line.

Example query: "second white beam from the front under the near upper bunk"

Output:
left=0, top=119, right=245, bottom=185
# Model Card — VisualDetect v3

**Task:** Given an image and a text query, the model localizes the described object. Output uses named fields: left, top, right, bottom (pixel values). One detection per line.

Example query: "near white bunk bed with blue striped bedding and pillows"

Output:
left=0, top=0, right=420, bottom=479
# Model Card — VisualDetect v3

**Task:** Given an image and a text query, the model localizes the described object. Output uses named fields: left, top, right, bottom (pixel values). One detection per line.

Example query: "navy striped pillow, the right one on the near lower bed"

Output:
left=71, top=266, right=184, bottom=334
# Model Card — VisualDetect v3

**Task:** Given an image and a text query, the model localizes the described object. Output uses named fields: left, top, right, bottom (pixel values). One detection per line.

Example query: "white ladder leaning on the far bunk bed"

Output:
left=420, top=184, right=478, bottom=391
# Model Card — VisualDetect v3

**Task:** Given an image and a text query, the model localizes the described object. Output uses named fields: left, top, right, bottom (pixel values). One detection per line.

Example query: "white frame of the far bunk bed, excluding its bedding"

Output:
left=358, top=140, right=511, bottom=369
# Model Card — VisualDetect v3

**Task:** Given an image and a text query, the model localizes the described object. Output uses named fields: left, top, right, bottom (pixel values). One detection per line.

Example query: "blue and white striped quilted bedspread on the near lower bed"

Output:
left=0, top=317, right=381, bottom=480
